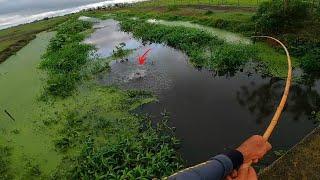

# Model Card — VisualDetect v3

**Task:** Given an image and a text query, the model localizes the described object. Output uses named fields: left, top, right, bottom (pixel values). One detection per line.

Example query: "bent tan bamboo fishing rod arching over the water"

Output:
left=251, top=36, right=292, bottom=140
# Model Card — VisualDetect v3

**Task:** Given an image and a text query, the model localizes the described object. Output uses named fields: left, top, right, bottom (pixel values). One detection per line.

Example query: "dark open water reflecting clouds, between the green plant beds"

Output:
left=87, top=20, right=320, bottom=164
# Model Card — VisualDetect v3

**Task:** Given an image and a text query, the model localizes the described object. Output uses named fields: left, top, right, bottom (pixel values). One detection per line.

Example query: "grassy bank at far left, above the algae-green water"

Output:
left=0, top=16, right=67, bottom=63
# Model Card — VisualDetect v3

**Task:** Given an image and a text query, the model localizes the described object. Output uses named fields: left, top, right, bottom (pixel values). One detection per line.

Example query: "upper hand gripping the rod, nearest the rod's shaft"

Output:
left=237, top=135, right=272, bottom=164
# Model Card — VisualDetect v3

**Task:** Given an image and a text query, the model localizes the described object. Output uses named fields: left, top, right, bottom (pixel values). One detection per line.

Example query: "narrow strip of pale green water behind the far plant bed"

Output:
left=148, top=19, right=251, bottom=44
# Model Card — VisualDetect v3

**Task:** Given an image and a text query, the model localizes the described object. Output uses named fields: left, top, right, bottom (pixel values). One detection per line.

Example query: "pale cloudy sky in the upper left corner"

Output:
left=0, top=0, right=141, bottom=29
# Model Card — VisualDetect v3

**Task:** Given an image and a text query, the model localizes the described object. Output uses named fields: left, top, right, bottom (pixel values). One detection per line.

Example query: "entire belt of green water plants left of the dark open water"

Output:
left=36, top=16, right=182, bottom=179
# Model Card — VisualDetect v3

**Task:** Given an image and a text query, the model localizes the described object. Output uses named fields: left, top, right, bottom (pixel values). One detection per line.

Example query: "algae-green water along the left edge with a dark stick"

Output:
left=0, top=32, right=60, bottom=177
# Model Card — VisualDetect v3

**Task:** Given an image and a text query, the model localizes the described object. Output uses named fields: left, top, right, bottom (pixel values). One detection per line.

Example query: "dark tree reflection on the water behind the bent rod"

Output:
left=237, top=78, right=320, bottom=124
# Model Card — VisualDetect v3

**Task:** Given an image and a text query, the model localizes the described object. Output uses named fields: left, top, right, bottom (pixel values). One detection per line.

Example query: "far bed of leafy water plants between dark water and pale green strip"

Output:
left=120, top=18, right=256, bottom=73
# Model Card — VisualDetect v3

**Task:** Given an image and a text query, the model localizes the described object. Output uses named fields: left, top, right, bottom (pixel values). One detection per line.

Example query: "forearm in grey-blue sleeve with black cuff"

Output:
left=168, top=150, right=243, bottom=180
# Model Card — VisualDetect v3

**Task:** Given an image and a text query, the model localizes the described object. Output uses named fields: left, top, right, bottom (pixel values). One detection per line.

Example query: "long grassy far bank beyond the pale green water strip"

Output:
left=84, top=6, right=255, bottom=35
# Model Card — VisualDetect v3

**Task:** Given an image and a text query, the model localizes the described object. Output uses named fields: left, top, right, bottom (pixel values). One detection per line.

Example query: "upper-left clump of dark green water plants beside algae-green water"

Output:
left=40, top=19, right=94, bottom=97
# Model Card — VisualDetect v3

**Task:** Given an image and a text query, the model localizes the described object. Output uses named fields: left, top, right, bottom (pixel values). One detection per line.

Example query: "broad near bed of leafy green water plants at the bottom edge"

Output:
left=48, top=86, right=182, bottom=179
